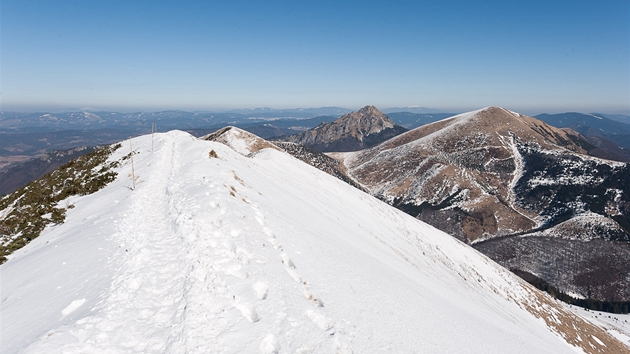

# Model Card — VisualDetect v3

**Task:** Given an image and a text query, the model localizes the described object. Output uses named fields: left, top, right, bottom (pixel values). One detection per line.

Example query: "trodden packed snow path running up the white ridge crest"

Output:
left=56, top=138, right=195, bottom=352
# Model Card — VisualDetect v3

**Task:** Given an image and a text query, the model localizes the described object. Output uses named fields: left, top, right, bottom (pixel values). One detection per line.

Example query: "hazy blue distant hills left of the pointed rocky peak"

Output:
left=0, top=107, right=340, bottom=165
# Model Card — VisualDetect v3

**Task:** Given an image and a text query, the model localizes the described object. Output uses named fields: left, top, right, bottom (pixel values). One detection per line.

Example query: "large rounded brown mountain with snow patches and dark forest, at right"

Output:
left=343, top=107, right=630, bottom=301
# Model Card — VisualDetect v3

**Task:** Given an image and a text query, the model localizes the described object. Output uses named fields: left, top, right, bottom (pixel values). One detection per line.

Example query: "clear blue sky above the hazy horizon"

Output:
left=0, top=0, right=630, bottom=114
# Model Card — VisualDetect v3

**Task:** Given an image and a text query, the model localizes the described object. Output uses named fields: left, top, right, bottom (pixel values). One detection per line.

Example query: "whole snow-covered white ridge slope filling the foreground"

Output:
left=0, top=131, right=626, bottom=353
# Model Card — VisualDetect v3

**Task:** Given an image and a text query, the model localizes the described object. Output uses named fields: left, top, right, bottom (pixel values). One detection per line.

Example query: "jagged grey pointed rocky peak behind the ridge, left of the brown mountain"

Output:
left=281, top=106, right=407, bottom=151
